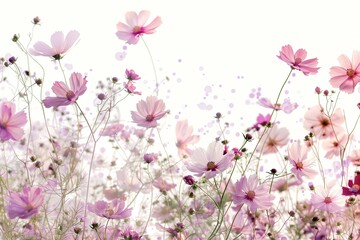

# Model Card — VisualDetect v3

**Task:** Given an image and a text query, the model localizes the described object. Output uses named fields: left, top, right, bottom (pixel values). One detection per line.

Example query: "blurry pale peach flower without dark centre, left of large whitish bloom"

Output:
left=176, top=120, right=200, bottom=157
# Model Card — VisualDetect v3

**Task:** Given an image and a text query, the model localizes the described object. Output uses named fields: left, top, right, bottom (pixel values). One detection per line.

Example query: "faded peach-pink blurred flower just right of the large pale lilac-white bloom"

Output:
left=258, top=125, right=290, bottom=154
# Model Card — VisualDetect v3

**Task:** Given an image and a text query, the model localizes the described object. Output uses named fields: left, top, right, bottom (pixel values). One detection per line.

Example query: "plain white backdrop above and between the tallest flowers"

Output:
left=0, top=0, right=360, bottom=145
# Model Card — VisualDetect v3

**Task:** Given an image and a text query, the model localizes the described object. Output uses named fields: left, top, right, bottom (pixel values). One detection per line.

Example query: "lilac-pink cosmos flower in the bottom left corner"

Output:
left=6, top=187, right=44, bottom=219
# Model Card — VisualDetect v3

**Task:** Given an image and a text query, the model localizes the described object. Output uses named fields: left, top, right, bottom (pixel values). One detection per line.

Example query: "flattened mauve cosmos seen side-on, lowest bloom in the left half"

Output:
left=88, top=199, right=132, bottom=219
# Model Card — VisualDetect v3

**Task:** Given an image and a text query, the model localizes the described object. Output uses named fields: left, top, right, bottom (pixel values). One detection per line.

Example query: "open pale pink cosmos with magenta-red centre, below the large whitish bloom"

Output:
left=232, top=174, right=275, bottom=213
